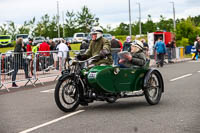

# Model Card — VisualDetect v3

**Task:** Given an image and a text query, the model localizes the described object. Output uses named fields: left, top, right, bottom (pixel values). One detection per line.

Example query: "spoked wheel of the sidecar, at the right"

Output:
left=144, top=71, right=163, bottom=105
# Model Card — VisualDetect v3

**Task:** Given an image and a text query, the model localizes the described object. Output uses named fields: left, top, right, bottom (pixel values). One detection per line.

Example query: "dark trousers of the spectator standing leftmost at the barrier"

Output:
left=12, top=61, right=28, bottom=83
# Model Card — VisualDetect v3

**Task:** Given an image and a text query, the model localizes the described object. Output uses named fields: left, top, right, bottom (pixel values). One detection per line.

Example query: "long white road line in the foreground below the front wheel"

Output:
left=19, top=110, right=85, bottom=133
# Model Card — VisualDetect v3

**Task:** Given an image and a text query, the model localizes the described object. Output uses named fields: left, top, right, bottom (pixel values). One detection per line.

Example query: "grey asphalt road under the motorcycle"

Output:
left=0, top=61, right=200, bottom=133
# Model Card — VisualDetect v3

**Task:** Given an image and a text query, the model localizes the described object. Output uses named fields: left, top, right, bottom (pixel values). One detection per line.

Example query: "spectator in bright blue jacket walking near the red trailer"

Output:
left=155, top=37, right=166, bottom=67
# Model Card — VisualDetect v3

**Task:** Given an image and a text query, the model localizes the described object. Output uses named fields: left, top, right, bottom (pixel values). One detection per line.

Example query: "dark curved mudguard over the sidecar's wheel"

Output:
left=143, top=68, right=164, bottom=92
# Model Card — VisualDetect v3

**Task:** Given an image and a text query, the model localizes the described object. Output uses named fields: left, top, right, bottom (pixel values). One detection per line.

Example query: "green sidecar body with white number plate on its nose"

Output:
left=87, top=61, right=149, bottom=93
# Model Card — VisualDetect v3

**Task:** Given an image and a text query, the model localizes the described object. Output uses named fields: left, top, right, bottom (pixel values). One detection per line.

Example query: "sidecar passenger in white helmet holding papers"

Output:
left=119, top=40, right=146, bottom=68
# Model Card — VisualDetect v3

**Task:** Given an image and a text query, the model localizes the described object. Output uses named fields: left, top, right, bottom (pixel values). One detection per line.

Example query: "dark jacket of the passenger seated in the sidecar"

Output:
left=124, top=51, right=146, bottom=67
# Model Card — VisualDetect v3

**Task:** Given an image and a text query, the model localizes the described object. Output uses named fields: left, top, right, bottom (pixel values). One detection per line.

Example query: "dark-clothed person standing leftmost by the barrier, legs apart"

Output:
left=12, top=38, right=30, bottom=87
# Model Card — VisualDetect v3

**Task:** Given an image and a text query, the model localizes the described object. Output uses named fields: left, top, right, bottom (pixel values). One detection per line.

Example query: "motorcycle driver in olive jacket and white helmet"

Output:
left=77, top=27, right=113, bottom=66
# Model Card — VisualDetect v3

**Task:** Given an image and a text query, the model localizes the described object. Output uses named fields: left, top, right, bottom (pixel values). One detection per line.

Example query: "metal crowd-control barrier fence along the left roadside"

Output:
left=0, top=51, right=75, bottom=91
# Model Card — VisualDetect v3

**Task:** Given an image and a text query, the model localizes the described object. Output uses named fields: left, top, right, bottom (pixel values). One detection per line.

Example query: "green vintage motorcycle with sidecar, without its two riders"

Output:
left=54, top=57, right=164, bottom=112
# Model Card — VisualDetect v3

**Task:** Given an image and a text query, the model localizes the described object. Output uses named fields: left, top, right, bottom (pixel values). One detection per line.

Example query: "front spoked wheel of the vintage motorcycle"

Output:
left=54, top=76, right=80, bottom=112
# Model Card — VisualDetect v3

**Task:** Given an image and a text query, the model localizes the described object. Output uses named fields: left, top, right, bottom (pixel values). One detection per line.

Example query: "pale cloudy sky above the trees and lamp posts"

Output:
left=0, top=0, right=200, bottom=28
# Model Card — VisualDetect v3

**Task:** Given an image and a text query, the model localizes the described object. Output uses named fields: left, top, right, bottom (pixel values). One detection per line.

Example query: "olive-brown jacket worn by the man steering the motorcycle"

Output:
left=85, top=37, right=113, bottom=65
